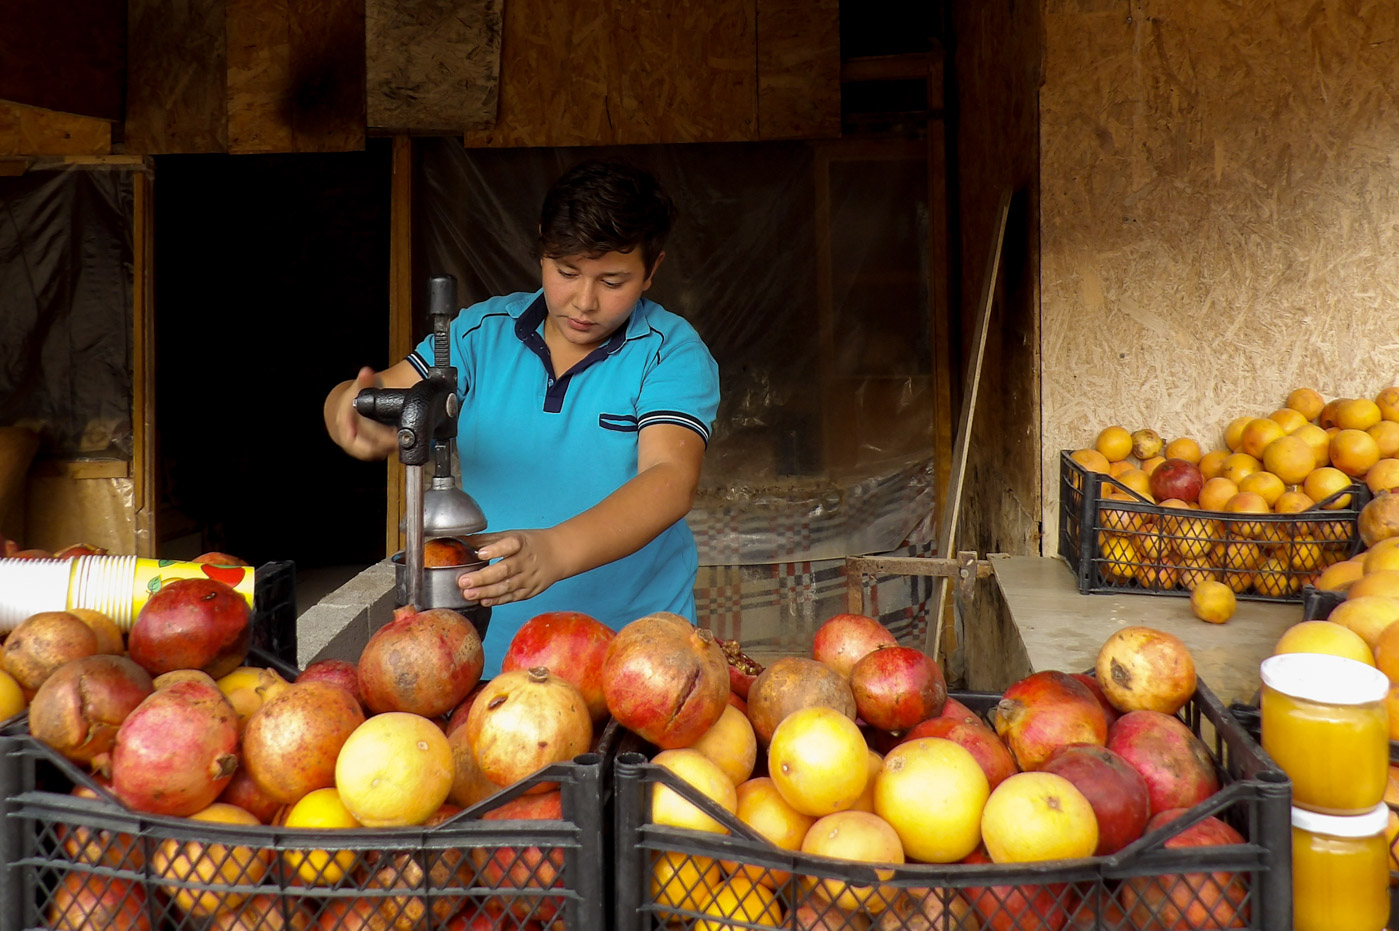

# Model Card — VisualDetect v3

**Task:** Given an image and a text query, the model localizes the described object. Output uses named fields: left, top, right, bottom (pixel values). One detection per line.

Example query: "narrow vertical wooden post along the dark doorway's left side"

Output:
left=132, top=172, right=158, bottom=556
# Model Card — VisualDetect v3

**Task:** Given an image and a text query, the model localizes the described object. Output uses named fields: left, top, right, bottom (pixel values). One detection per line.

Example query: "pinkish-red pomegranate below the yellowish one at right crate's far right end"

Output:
left=1108, top=711, right=1220, bottom=815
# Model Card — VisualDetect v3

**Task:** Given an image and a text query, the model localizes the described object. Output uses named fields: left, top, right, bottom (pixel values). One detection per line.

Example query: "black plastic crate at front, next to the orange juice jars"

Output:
left=611, top=674, right=1293, bottom=931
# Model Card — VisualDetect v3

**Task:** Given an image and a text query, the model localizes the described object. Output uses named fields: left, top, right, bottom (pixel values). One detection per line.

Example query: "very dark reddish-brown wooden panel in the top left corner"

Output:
left=0, top=0, right=126, bottom=122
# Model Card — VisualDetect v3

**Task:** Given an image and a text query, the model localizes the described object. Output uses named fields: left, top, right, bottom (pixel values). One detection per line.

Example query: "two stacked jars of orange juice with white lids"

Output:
left=1259, top=652, right=1389, bottom=931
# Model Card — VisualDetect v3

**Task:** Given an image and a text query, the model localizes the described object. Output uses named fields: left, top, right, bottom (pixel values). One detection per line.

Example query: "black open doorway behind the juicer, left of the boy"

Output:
left=154, top=140, right=392, bottom=570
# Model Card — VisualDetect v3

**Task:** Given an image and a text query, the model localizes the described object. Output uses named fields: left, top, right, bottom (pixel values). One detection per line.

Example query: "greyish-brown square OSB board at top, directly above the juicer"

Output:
left=364, top=0, right=505, bottom=134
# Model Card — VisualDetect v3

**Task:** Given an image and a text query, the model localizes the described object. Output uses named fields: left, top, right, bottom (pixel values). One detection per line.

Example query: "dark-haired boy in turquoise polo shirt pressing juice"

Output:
left=325, top=161, right=719, bottom=675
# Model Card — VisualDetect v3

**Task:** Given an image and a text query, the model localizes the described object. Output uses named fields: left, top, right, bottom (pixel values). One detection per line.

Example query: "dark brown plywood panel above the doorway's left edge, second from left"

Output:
left=125, top=0, right=228, bottom=155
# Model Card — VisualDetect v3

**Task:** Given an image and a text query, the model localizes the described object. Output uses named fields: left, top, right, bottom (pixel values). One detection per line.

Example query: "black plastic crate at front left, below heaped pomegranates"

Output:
left=0, top=651, right=617, bottom=931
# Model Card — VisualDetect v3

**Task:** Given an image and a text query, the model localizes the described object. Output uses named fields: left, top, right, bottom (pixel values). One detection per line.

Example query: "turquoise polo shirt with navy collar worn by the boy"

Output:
left=409, top=291, right=719, bottom=675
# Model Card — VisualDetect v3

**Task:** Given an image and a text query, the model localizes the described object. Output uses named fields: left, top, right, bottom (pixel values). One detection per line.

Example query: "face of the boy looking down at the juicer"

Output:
left=539, top=249, right=665, bottom=350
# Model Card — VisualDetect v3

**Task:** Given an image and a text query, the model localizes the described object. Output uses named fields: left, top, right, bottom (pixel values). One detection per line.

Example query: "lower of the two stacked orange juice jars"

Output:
left=1293, top=802, right=1389, bottom=931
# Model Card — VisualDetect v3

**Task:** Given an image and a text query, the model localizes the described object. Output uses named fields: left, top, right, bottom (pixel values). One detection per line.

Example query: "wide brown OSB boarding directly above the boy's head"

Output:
left=464, top=0, right=839, bottom=146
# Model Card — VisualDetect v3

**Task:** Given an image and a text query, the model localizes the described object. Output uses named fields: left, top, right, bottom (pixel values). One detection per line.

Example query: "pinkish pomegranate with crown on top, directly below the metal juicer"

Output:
left=360, top=605, right=485, bottom=718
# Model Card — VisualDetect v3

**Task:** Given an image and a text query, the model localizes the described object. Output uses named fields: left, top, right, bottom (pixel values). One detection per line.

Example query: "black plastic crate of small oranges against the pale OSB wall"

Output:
left=1059, top=451, right=1371, bottom=602
